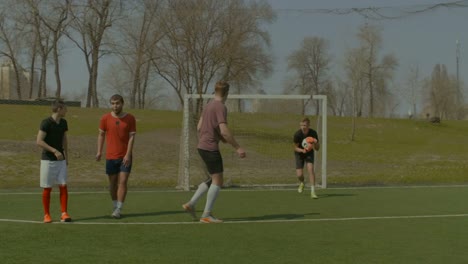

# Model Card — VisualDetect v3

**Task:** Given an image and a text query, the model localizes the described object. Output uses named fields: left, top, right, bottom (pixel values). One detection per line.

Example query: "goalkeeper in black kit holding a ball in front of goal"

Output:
left=293, top=117, right=320, bottom=199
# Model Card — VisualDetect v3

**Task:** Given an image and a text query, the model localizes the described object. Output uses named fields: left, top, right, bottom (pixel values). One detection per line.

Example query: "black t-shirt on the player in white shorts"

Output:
left=39, top=117, right=68, bottom=160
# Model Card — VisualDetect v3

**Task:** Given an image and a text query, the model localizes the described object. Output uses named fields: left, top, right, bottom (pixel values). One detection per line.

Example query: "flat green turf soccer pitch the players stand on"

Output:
left=0, top=186, right=468, bottom=263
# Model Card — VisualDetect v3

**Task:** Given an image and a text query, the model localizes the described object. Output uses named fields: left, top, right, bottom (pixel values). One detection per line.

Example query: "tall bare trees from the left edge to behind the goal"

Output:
left=0, top=0, right=275, bottom=108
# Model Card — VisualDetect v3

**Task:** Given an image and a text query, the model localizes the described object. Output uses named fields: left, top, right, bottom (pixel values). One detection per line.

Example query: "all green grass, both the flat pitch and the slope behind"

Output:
left=0, top=105, right=468, bottom=263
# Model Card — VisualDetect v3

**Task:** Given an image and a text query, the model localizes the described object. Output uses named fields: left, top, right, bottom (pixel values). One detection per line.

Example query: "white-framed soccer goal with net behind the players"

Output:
left=177, top=94, right=327, bottom=190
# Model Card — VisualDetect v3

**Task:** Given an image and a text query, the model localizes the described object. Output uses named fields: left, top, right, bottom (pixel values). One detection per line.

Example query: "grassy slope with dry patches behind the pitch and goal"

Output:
left=0, top=105, right=468, bottom=189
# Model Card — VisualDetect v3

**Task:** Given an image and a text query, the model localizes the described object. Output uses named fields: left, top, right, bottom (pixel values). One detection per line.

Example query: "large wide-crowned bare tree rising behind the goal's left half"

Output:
left=152, top=0, right=274, bottom=113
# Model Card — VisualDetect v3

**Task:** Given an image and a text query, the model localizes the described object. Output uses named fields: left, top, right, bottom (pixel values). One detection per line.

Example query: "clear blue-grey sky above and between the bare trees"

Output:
left=55, top=0, right=468, bottom=113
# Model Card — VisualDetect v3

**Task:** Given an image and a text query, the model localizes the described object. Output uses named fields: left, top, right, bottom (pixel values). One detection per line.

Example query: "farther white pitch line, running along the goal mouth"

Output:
left=0, top=184, right=468, bottom=195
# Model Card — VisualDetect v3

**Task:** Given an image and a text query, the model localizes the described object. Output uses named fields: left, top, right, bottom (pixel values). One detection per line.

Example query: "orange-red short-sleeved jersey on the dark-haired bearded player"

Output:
left=99, top=113, right=136, bottom=159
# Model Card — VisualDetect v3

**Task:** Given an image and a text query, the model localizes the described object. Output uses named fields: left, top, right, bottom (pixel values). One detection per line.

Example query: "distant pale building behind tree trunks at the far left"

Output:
left=0, top=60, right=39, bottom=100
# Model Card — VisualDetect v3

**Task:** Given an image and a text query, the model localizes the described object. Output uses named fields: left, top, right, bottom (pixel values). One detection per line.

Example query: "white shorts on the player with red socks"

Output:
left=40, top=160, right=67, bottom=188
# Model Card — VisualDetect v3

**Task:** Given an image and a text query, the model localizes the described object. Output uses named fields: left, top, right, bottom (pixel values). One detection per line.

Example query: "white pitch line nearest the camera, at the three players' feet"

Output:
left=0, top=214, right=468, bottom=225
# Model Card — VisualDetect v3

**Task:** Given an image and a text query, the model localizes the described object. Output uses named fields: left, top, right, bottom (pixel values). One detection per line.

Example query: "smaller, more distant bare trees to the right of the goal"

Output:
left=285, top=22, right=466, bottom=119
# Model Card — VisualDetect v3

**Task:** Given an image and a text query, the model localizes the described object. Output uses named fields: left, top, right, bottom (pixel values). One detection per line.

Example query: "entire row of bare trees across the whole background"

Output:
left=0, top=0, right=464, bottom=118
